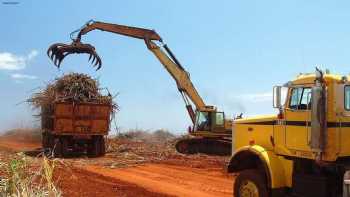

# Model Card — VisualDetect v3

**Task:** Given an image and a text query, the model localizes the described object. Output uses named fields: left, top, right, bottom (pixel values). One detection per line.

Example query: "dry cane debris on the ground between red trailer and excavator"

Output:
left=105, top=129, right=227, bottom=168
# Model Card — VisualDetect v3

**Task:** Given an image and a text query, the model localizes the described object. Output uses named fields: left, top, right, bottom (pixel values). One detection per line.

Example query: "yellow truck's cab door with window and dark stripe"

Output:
left=285, top=87, right=311, bottom=151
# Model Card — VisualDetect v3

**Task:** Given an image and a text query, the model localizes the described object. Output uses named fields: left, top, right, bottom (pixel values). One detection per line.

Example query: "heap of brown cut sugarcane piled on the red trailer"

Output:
left=27, top=73, right=119, bottom=128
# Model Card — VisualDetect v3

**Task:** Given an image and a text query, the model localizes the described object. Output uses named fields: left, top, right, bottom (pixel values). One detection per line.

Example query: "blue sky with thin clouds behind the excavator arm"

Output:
left=0, top=0, right=350, bottom=133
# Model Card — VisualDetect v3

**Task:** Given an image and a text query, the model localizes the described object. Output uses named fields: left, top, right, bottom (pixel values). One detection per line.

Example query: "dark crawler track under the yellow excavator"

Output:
left=175, top=138, right=231, bottom=156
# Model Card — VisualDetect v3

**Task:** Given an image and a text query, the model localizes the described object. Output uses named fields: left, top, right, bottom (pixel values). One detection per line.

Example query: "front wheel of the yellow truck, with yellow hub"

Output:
left=233, top=169, right=268, bottom=197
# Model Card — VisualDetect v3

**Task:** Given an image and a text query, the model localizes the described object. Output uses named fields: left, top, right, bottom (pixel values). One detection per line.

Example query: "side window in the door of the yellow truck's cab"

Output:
left=289, top=87, right=311, bottom=110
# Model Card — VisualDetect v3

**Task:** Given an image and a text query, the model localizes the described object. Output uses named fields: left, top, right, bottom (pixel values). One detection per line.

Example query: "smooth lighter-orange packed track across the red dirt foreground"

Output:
left=84, top=164, right=233, bottom=197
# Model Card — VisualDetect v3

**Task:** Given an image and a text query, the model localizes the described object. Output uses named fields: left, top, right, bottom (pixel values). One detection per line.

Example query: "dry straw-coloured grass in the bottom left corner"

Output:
left=0, top=153, right=61, bottom=197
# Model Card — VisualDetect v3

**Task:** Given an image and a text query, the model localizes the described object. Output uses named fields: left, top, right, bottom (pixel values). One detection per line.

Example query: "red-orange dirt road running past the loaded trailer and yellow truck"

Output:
left=0, top=138, right=233, bottom=197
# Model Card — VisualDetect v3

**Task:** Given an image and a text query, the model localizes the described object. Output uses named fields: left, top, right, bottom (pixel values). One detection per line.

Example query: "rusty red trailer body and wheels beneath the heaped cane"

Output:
left=41, top=102, right=112, bottom=157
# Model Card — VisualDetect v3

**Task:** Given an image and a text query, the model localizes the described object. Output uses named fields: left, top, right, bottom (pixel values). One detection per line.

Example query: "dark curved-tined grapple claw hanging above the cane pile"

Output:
left=47, top=41, right=102, bottom=70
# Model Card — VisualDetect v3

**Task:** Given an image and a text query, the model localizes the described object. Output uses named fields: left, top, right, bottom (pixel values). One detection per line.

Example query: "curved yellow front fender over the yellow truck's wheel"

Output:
left=227, top=145, right=286, bottom=189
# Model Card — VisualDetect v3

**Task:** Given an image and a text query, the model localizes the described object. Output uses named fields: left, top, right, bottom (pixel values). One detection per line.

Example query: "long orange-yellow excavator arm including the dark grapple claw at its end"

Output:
left=48, top=21, right=212, bottom=123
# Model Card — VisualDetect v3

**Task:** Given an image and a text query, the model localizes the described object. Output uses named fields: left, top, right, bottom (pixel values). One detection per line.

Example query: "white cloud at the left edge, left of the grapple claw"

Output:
left=0, top=50, right=39, bottom=70
